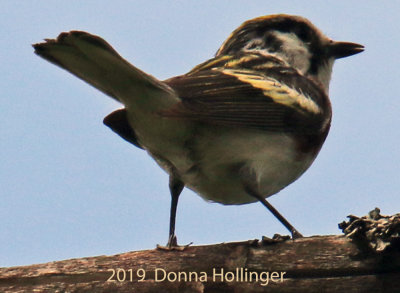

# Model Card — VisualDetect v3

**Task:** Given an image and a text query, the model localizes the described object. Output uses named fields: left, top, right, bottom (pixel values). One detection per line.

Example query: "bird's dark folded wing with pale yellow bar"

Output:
left=161, top=67, right=331, bottom=133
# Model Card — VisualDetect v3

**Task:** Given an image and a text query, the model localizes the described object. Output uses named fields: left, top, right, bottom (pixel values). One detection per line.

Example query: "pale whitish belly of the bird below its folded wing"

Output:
left=167, top=129, right=315, bottom=204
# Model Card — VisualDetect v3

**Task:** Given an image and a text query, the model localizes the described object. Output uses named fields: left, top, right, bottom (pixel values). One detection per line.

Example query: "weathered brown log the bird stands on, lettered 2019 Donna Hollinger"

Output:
left=0, top=236, right=400, bottom=292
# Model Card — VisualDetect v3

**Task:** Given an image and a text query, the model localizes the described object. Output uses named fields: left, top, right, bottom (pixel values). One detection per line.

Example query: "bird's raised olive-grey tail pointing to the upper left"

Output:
left=33, top=31, right=177, bottom=104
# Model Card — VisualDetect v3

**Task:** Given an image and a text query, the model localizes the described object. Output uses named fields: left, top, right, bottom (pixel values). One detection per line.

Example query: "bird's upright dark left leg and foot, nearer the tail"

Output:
left=157, top=174, right=190, bottom=250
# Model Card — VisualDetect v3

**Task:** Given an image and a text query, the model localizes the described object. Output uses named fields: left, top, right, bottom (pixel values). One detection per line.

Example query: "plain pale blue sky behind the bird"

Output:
left=0, top=0, right=400, bottom=266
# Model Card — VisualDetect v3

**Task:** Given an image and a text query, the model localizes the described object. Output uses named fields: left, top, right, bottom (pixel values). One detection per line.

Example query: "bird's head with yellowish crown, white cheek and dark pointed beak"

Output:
left=216, top=14, right=364, bottom=92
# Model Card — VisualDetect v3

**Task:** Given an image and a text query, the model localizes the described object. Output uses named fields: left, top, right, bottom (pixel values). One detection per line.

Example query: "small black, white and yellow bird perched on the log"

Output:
left=33, top=14, right=364, bottom=250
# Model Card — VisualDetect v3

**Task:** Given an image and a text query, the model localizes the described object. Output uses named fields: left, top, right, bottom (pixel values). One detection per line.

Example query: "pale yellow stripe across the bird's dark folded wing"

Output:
left=221, top=69, right=322, bottom=114
